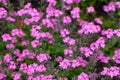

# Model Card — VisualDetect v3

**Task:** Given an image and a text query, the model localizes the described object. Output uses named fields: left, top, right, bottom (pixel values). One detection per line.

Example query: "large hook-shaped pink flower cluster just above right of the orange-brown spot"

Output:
left=16, top=3, right=42, bottom=25
